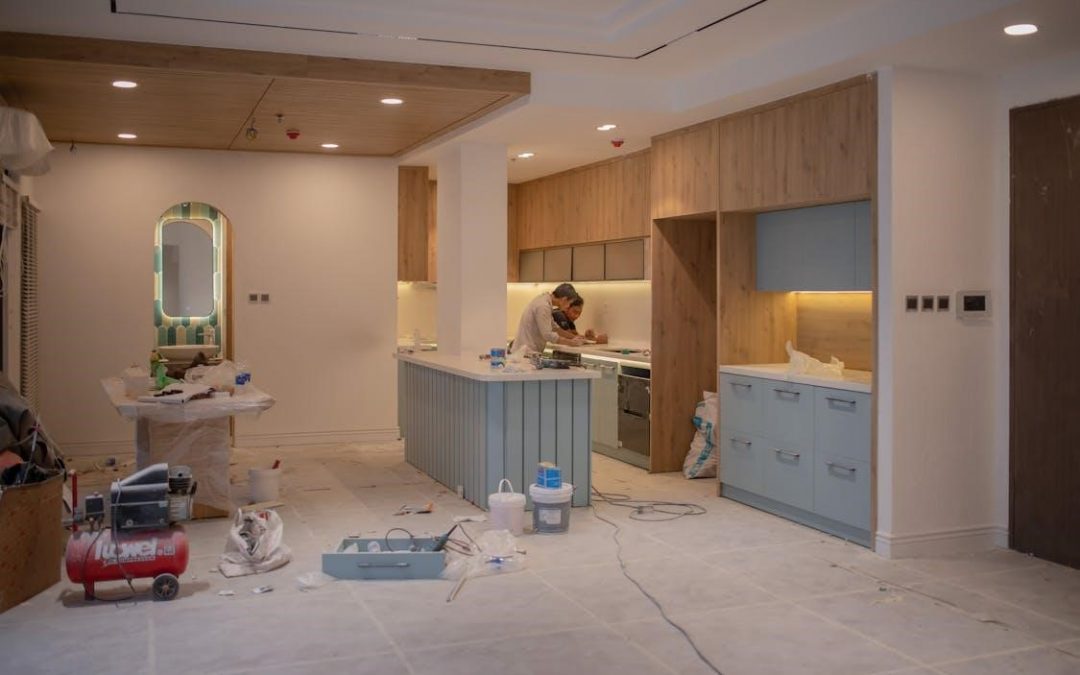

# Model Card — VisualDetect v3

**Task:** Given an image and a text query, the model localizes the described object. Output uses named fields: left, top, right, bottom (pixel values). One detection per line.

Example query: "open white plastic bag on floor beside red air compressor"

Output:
left=218, top=510, right=293, bottom=578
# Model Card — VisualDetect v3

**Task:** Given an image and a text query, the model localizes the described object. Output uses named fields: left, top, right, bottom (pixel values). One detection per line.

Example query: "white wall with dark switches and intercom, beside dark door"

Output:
left=877, top=68, right=1004, bottom=556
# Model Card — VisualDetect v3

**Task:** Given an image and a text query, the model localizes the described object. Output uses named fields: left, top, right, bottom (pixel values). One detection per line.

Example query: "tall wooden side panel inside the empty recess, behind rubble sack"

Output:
left=649, top=218, right=716, bottom=472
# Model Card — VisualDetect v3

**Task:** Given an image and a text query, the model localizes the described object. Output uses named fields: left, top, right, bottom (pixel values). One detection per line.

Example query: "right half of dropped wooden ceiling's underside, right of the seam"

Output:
left=232, top=78, right=505, bottom=156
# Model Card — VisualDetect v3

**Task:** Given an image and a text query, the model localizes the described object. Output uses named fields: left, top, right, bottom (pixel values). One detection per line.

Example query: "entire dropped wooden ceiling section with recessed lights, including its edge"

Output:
left=0, top=32, right=530, bottom=157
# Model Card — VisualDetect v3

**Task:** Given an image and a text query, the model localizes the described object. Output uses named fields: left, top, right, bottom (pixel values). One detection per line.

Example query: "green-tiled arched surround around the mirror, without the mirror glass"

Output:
left=153, top=202, right=229, bottom=354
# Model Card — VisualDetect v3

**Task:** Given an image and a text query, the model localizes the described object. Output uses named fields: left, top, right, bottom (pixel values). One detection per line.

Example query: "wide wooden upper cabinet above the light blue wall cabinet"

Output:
left=719, top=78, right=877, bottom=212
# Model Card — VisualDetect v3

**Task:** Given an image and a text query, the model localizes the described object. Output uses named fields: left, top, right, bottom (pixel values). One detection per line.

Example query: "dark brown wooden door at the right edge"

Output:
left=1009, top=96, right=1080, bottom=567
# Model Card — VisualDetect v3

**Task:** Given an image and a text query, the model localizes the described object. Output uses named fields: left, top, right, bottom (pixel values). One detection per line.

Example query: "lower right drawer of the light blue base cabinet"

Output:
left=813, top=453, right=870, bottom=530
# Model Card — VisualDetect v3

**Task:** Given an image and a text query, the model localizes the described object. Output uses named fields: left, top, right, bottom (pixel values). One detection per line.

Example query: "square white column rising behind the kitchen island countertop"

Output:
left=435, top=143, right=507, bottom=355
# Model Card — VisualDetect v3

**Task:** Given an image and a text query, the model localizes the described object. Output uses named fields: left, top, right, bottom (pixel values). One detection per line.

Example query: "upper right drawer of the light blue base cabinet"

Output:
left=813, top=387, right=870, bottom=462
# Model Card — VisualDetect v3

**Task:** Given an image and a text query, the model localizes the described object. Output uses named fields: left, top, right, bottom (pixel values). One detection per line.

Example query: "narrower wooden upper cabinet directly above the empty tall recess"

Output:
left=650, top=120, right=719, bottom=218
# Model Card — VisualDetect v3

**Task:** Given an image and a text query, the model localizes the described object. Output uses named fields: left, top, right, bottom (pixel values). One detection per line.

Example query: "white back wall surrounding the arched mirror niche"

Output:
left=33, top=145, right=397, bottom=454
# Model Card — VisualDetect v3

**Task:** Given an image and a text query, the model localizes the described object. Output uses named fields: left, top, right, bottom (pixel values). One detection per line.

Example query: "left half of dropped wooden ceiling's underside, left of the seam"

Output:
left=0, top=58, right=271, bottom=149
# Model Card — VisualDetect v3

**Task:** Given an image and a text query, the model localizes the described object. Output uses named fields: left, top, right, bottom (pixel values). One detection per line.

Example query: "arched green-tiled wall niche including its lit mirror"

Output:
left=153, top=202, right=230, bottom=359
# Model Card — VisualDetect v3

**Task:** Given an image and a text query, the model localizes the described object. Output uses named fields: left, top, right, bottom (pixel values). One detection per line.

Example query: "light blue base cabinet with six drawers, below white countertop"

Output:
left=719, top=373, right=870, bottom=546
